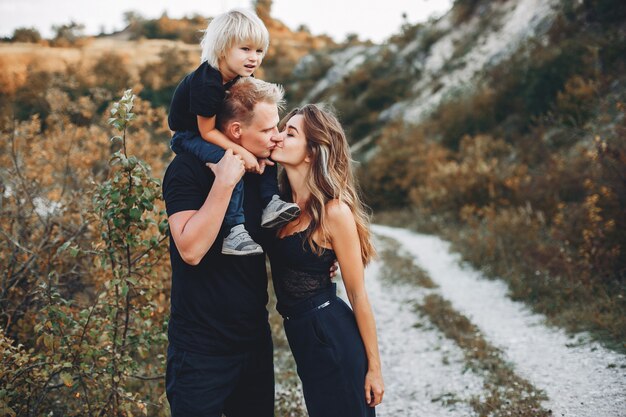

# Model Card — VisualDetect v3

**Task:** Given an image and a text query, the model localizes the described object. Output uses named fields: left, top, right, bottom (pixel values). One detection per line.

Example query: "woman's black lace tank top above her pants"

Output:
left=268, top=231, right=336, bottom=315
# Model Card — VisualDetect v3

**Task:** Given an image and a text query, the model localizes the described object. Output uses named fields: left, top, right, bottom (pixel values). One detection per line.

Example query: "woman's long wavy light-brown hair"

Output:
left=279, top=104, right=376, bottom=265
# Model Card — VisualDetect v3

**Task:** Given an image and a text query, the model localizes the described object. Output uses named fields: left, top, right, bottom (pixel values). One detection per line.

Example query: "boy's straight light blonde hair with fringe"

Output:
left=200, top=9, right=270, bottom=69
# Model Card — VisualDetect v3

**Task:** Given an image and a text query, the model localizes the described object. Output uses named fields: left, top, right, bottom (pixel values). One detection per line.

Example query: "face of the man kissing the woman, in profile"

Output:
left=239, top=102, right=279, bottom=158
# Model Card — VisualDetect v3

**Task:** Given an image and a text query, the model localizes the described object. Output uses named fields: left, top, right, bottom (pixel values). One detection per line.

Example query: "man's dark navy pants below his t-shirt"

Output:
left=165, top=334, right=274, bottom=417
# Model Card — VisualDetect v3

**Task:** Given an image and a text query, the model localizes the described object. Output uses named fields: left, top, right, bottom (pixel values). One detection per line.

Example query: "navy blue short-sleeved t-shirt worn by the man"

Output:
left=163, top=153, right=270, bottom=355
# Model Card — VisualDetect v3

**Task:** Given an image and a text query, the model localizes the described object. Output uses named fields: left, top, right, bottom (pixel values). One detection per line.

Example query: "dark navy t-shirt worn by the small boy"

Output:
left=167, top=61, right=239, bottom=133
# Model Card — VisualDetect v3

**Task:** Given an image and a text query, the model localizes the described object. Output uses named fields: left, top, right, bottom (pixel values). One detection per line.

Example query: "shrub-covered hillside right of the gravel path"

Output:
left=360, top=2, right=626, bottom=350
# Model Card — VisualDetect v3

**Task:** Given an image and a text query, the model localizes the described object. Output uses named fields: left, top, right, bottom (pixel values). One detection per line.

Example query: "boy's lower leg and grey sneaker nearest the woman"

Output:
left=260, top=165, right=300, bottom=228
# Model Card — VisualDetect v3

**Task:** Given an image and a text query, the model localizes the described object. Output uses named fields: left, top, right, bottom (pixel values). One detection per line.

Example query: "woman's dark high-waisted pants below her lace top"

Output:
left=284, top=292, right=376, bottom=417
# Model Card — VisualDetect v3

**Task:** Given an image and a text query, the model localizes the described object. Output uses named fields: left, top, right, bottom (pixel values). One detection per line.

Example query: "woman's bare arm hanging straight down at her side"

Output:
left=326, top=200, right=385, bottom=407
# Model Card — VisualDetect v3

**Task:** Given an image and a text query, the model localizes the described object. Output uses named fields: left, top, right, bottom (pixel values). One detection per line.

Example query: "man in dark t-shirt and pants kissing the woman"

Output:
left=163, top=77, right=283, bottom=417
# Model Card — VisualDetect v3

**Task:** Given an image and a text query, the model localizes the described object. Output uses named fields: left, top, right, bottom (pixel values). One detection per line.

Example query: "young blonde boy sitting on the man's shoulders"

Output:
left=168, top=9, right=300, bottom=255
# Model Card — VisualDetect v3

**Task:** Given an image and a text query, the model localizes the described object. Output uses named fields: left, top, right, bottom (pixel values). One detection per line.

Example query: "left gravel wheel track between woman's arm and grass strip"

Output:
left=346, top=262, right=483, bottom=417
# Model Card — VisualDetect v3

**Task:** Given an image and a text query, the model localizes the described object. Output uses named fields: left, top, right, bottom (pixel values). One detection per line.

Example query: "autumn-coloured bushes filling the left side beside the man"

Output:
left=0, top=57, right=169, bottom=416
